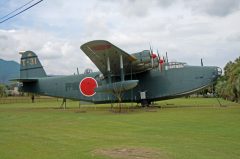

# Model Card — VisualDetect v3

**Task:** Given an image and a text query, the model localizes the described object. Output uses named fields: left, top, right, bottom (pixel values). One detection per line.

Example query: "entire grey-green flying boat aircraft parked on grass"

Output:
left=14, top=40, right=221, bottom=105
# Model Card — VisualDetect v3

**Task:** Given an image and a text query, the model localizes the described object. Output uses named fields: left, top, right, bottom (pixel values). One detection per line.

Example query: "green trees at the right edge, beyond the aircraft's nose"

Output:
left=215, top=56, right=240, bottom=102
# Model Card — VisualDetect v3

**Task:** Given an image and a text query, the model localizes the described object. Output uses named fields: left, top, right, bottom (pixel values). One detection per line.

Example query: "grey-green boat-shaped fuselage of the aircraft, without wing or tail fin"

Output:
left=22, top=65, right=219, bottom=103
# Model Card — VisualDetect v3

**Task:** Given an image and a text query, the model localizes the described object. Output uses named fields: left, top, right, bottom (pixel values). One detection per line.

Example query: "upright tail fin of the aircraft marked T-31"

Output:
left=20, top=51, right=47, bottom=79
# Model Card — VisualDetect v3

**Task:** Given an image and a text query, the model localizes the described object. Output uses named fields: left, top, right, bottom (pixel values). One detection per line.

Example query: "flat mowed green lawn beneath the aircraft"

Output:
left=0, top=98, right=240, bottom=159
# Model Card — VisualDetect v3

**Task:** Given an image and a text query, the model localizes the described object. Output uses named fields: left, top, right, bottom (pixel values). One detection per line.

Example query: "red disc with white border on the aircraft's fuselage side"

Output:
left=79, top=77, right=98, bottom=97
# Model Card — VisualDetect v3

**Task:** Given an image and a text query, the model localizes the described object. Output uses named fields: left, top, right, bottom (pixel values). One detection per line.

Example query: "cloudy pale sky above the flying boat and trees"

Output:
left=0, top=0, right=240, bottom=74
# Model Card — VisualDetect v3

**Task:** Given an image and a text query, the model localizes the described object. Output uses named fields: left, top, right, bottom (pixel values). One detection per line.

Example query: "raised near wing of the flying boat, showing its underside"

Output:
left=81, top=40, right=150, bottom=76
